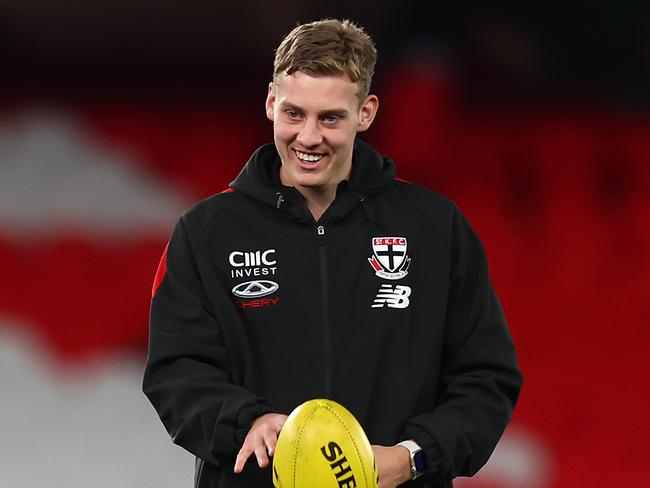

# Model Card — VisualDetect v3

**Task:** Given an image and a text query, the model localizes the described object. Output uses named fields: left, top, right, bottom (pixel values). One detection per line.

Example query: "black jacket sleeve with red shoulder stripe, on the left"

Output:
left=143, top=218, right=277, bottom=466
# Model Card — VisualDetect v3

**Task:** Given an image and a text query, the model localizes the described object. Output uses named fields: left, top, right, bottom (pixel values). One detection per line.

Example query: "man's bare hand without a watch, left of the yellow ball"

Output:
left=235, top=413, right=287, bottom=473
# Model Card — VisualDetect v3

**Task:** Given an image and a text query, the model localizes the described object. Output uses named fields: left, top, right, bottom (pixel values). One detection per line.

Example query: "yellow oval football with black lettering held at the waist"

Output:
left=273, top=399, right=378, bottom=488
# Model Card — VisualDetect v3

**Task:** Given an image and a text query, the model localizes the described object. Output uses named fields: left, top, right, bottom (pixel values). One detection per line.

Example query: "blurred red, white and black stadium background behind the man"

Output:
left=0, top=0, right=650, bottom=488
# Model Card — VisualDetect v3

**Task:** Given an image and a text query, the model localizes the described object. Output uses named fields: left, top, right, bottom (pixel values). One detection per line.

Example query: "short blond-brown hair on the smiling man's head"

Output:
left=273, top=19, right=377, bottom=103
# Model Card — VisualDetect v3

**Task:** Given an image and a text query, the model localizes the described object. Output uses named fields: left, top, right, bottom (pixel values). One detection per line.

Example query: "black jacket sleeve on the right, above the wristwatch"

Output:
left=402, top=208, right=522, bottom=480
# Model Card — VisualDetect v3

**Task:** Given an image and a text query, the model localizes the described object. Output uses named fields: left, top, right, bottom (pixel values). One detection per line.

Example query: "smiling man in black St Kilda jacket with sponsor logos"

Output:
left=144, top=20, right=521, bottom=488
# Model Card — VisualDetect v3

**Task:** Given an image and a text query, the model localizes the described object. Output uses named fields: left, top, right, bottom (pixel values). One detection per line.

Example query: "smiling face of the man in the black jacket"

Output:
left=266, top=71, right=378, bottom=198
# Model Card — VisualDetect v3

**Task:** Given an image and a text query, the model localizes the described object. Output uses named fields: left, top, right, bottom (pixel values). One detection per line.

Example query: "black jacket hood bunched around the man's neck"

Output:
left=230, top=139, right=395, bottom=213
